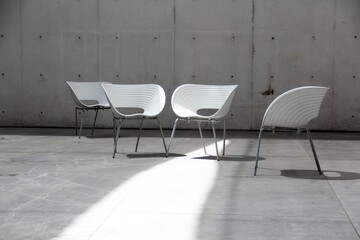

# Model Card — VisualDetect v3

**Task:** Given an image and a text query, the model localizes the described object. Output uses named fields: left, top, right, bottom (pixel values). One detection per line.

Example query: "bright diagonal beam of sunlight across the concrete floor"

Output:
left=52, top=140, right=230, bottom=240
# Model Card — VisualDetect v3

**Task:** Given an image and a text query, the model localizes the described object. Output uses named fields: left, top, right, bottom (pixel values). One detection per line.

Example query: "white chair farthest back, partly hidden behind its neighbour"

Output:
left=66, top=81, right=110, bottom=138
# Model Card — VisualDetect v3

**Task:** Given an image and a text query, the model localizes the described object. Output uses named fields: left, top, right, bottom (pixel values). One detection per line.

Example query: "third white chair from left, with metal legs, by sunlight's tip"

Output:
left=166, top=84, right=238, bottom=161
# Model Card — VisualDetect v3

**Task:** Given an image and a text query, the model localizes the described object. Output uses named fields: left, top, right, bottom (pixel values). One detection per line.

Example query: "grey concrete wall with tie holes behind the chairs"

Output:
left=0, top=0, right=360, bottom=131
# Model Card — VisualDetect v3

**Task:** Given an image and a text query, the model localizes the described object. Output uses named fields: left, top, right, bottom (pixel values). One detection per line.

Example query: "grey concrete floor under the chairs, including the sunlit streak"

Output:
left=0, top=128, right=360, bottom=240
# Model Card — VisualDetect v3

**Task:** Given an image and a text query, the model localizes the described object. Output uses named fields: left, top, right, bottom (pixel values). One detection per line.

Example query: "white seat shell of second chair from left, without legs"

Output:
left=102, top=84, right=166, bottom=117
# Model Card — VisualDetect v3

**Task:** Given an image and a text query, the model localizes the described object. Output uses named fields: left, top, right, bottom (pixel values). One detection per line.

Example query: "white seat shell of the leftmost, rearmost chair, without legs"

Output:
left=66, top=81, right=111, bottom=107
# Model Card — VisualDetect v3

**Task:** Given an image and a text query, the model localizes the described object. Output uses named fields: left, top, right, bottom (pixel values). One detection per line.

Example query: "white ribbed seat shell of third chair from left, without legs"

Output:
left=171, top=84, right=238, bottom=119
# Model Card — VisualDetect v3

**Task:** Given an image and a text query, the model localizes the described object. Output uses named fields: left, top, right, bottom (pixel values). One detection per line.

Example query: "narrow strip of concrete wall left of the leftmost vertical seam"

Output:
left=0, top=0, right=23, bottom=126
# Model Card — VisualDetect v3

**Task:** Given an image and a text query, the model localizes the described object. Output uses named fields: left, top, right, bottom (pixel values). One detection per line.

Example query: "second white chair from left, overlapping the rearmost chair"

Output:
left=102, top=84, right=167, bottom=158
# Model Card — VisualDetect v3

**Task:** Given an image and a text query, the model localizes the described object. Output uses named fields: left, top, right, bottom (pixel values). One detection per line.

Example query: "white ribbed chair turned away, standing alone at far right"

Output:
left=254, top=86, right=329, bottom=176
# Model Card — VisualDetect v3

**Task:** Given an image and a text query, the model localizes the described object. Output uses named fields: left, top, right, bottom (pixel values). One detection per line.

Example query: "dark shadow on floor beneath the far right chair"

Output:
left=281, top=169, right=360, bottom=180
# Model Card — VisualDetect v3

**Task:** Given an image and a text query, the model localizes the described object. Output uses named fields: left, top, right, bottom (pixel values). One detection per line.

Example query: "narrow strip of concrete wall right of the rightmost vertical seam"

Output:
left=332, top=0, right=360, bottom=130
